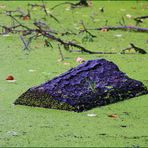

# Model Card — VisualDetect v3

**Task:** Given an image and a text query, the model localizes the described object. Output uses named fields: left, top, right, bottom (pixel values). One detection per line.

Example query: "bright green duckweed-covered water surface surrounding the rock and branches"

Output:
left=0, top=1, right=148, bottom=147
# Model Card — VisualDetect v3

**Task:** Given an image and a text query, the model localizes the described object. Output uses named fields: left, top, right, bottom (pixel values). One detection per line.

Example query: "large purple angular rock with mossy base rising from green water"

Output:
left=15, top=59, right=148, bottom=112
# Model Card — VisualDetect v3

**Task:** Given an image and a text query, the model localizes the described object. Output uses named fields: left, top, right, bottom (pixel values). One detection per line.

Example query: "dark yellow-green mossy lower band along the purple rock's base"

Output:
left=14, top=84, right=148, bottom=112
